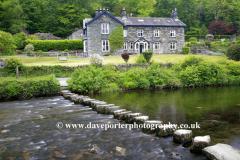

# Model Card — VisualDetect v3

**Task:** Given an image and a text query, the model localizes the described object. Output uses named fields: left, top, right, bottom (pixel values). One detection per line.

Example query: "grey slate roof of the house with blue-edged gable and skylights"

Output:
left=85, top=11, right=187, bottom=27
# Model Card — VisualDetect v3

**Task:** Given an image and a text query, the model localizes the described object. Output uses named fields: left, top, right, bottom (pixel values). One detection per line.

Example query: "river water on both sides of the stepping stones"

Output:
left=0, top=86, right=240, bottom=160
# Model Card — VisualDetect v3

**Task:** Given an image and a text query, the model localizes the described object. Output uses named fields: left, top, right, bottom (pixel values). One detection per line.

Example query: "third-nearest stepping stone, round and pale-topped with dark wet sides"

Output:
left=173, top=129, right=192, bottom=143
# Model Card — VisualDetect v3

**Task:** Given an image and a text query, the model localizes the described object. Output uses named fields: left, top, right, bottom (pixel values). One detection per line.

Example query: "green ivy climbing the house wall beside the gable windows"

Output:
left=108, top=24, right=124, bottom=53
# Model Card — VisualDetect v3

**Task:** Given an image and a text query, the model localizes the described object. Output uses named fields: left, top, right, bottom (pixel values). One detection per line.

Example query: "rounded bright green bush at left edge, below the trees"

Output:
left=0, top=31, right=16, bottom=55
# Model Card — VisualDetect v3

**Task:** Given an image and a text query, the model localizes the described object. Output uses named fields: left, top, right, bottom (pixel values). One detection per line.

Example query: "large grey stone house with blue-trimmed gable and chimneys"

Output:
left=83, top=8, right=186, bottom=56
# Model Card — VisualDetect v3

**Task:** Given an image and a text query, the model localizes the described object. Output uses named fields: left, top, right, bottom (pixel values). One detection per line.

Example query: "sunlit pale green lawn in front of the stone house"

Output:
left=1, top=55, right=227, bottom=66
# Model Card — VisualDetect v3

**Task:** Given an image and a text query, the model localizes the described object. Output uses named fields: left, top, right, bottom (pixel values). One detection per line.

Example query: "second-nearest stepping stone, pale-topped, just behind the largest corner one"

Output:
left=190, top=135, right=211, bottom=153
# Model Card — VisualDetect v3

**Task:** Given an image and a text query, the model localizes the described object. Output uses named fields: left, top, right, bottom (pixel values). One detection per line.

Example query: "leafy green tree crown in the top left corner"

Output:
left=2, top=0, right=26, bottom=33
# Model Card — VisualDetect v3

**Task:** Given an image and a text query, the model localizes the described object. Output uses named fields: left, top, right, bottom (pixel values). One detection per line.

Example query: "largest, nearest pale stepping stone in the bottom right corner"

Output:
left=202, top=143, right=240, bottom=160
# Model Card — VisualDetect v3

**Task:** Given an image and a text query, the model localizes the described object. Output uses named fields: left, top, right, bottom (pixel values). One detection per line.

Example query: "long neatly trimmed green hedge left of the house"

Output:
left=26, top=39, right=83, bottom=51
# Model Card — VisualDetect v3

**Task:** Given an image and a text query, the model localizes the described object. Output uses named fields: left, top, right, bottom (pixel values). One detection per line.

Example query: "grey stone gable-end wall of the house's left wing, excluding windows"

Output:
left=84, top=14, right=119, bottom=56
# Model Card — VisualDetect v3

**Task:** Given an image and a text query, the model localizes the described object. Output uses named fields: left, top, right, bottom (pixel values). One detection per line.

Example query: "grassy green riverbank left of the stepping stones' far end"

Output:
left=0, top=75, right=61, bottom=100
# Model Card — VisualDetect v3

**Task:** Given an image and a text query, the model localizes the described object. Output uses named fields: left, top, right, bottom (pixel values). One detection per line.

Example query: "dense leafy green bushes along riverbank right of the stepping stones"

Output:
left=68, top=55, right=240, bottom=93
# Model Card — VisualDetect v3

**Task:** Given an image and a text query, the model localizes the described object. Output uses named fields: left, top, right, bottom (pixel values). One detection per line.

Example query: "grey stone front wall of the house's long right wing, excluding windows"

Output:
left=124, top=26, right=185, bottom=54
